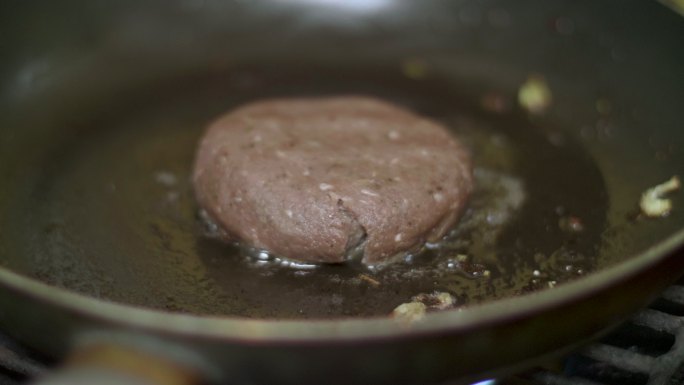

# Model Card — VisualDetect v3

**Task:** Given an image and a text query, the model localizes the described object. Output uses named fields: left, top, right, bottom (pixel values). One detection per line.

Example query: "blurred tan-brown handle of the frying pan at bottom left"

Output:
left=33, top=343, right=203, bottom=385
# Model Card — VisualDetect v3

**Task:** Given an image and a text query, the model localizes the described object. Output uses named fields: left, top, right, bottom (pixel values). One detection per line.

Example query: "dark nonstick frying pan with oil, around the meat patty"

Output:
left=0, top=0, right=684, bottom=384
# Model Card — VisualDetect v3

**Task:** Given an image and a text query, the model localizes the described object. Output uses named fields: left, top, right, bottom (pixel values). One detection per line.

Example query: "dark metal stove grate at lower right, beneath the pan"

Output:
left=524, top=281, right=684, bottom=385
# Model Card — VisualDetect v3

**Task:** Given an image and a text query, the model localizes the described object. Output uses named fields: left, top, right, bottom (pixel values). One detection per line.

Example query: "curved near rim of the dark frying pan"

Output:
left=0, top=228, right=684, bottom=344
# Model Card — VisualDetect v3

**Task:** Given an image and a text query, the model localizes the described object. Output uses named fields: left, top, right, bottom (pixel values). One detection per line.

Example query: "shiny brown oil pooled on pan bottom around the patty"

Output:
left=4, top=68, right=607, bottom=318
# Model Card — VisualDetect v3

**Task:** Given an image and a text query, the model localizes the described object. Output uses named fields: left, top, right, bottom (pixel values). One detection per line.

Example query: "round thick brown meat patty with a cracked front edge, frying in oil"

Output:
left=194, top=96, right=472, bottom=264
